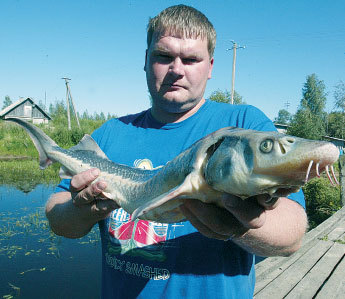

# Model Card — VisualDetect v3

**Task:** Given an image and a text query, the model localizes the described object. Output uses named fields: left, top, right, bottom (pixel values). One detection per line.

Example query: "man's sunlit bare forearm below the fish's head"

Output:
left=233, top=198, right=308, bottom=256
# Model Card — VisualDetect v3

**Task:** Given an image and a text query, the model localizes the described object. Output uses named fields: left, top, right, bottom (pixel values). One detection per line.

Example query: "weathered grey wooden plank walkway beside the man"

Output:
left=254, top=207, right=345, bottom=299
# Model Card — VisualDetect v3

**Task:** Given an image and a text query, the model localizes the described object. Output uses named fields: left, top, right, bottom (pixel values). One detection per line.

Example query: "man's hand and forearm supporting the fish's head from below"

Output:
left=180, top=194, right=307, bottom=256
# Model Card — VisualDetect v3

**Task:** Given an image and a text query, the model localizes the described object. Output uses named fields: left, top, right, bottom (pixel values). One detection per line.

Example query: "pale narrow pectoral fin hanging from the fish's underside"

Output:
left=132, top=175, right=192, bottom=221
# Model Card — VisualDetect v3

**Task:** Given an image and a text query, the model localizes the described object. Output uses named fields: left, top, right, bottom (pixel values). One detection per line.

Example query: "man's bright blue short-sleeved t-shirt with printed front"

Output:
left=58, top=101, right=304, bottom=299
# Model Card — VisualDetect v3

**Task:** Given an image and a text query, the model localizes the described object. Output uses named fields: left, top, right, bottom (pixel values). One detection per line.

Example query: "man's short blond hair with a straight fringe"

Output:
left=147, top=4, right=216, bottom=58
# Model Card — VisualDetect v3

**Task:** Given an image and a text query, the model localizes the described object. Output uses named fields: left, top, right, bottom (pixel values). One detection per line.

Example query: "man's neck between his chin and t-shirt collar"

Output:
left=151, top=98, right=205, bottom=124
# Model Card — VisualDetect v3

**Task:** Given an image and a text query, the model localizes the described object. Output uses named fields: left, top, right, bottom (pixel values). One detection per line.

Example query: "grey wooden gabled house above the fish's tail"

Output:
left=0, top=98, right=51, bottom=124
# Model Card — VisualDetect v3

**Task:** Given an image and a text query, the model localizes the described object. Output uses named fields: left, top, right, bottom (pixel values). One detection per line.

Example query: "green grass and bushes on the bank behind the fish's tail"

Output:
left=0, top=102, right=113, bottom=192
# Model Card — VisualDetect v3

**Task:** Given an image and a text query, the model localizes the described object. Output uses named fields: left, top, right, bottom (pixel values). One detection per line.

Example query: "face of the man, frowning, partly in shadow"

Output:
left=145, top=34, right=213, bottom=120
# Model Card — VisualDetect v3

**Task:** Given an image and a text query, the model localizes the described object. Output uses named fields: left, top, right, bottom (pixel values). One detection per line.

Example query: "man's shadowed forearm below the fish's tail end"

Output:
left=46, top=192, right=98, bottom=238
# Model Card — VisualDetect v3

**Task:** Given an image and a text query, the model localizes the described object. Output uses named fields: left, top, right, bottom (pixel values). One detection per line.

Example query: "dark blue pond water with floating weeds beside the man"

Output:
left=0, top=185, right=101, bottom=298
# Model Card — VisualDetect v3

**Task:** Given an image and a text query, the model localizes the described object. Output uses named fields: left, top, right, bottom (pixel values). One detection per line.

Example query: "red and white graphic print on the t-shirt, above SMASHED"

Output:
left=108, top=159, right=183, bottom=261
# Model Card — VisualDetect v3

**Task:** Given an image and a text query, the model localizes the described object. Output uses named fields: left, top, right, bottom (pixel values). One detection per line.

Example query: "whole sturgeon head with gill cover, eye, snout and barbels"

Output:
left=204, top=130, right=339, bottom=198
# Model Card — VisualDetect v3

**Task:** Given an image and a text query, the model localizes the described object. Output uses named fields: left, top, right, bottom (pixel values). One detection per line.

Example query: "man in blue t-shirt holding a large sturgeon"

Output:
left=46, top=5, right=307, bottom=298
